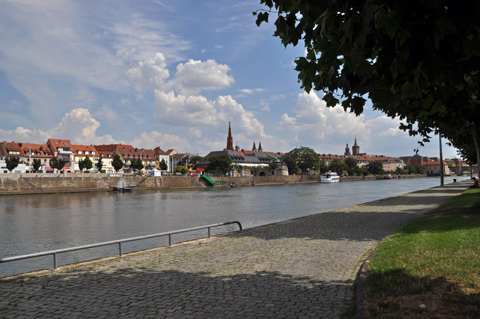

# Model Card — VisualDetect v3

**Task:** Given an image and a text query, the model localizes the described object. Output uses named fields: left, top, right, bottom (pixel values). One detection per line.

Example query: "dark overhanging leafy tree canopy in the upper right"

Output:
left=254, top=0, right=480, bottom=175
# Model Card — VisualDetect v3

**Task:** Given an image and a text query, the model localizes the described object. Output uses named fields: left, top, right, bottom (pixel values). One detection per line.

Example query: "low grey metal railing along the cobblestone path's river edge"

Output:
left=0, top=221, right=243, bottom=270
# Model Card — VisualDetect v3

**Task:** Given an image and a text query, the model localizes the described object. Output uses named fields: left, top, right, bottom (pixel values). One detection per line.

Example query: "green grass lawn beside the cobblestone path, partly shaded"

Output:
left=365, top=189, right=480, bottom=319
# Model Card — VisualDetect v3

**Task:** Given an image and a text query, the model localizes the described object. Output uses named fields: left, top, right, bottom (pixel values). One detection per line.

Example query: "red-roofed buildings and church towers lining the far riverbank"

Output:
left=0, top=121, right=467, bottom=175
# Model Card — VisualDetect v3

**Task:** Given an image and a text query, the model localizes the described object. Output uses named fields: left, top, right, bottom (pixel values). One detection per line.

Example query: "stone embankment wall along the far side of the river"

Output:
left=0, top=174, right=320, bottom=195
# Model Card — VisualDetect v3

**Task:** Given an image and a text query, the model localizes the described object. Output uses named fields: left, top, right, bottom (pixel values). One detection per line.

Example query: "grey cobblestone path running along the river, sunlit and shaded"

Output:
left=0, top=183, right=468, bottom=318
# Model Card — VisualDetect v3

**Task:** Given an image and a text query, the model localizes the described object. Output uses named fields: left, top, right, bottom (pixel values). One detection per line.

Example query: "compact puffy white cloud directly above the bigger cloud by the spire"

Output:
left=174, top=60, right=235, bottom=95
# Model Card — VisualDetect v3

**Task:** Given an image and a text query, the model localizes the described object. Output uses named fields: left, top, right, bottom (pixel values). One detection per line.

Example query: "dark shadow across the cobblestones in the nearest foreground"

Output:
left=0, top=267, right=353, bottom=318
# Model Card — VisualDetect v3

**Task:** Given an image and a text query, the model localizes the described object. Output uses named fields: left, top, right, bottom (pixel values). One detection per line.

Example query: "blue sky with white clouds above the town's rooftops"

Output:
left=0, top=0, right=457, bottom=158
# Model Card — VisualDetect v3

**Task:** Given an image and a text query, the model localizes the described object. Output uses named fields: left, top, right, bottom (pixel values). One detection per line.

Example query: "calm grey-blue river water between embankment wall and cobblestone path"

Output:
left=0, top=177, right=467, bottom=277
